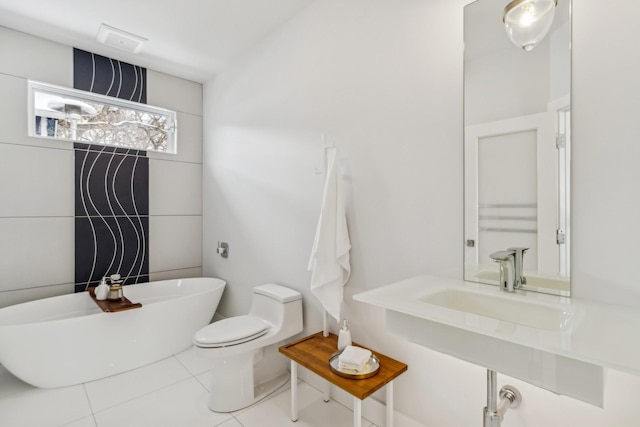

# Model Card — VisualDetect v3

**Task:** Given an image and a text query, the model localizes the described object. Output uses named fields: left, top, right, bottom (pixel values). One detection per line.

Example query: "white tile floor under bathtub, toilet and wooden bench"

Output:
left=0, top=349, right=375, bottom=427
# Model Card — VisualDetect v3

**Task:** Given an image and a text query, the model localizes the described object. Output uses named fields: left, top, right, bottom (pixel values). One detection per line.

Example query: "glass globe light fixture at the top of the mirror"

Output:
left=502, top=0, right=558, bottom=51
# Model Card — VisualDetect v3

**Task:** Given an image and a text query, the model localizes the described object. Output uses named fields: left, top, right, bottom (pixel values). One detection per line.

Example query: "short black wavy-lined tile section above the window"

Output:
left=73, top=48, right=147, bottom=104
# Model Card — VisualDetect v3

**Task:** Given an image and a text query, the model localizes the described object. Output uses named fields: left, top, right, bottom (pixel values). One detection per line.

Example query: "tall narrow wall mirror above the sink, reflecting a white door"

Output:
left=463, top=0, right=571, bottom=296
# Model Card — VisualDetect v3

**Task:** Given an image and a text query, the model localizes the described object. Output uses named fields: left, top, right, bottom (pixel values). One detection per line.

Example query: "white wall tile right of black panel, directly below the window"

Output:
left=149, top=159, right=202, bottom=215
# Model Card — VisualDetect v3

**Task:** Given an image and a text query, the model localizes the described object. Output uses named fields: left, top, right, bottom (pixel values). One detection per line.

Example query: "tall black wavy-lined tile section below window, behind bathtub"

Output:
left=74, top=144, right=149, bottom=292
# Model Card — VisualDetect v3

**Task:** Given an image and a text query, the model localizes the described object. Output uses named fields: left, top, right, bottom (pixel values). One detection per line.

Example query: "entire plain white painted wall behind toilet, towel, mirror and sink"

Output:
left=203, top=0, right=640, bottom=427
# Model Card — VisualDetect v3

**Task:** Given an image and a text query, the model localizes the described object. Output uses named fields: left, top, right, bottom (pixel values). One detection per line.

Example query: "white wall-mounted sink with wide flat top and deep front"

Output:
left=354, top=276, right=640, bottom=406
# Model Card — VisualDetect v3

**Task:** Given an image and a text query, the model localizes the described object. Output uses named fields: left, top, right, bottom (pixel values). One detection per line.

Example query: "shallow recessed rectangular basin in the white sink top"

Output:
left=420, top=289, right=573, bottom=331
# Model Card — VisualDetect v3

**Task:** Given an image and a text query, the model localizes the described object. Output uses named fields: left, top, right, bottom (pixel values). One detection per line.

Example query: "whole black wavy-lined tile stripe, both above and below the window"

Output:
left=73, top=49, right=149, bottom=292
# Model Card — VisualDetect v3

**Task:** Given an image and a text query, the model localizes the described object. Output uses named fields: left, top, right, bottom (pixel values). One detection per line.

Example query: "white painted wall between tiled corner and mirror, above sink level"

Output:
left=204, top=1, right=462, bottom=320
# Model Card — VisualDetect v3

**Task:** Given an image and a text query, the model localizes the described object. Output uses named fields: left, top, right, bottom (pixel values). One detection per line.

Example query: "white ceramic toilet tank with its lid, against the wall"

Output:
left=250, top=283, right=302, bottom=336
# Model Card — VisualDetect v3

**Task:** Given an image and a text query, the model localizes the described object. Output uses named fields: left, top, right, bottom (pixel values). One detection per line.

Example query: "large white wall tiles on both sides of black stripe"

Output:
left=0, top=27, right=202, bottom=307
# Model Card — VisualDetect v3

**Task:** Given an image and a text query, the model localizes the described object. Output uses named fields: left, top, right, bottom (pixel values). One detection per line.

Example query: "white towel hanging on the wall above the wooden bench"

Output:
left=308, top=147, right=351, bottom=322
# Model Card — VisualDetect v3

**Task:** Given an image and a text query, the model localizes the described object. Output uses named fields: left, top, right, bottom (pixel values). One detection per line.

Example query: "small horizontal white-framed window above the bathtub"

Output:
left=28, top=81, right=177, bottom=154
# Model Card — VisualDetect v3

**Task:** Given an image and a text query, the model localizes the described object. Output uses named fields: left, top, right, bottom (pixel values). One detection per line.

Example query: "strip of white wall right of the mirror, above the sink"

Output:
left=571, top=0, right=640, bottom=306
